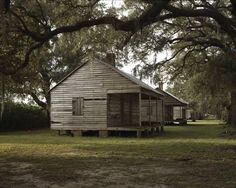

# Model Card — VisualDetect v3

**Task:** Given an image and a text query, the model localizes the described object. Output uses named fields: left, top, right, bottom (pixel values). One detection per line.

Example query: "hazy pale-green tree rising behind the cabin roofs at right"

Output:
left=167, top=67, right=230, bottom=123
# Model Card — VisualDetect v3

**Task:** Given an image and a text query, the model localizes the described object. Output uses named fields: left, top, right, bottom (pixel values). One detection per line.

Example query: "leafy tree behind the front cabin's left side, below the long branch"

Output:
left=0, top=0, right=123, bottom=115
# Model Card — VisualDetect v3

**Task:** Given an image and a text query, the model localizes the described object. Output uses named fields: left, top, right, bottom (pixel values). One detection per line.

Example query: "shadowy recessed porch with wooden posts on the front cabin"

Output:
left=107, top=91, right=163, bottom=136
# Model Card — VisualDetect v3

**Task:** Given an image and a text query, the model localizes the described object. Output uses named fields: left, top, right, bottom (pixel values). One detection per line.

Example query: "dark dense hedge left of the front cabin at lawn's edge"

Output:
left=0, top=102, right=49, bottom=131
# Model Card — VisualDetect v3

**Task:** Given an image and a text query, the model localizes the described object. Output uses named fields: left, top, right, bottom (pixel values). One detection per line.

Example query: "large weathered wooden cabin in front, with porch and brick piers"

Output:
left=50, top=59, right=164, bottom=136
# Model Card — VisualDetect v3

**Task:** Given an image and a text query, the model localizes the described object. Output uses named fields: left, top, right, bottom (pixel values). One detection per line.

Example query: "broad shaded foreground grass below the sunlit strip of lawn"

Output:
left=0, top=143, right=236, bottom=187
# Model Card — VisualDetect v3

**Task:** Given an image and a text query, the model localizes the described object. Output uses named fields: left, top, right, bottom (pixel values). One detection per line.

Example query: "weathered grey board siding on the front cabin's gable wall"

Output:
left=51, top=62, right=139, bottom=130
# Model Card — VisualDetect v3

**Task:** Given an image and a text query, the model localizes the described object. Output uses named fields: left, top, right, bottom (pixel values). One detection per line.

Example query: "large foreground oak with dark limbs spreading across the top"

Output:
left=1, top=0, right=236, bottom=124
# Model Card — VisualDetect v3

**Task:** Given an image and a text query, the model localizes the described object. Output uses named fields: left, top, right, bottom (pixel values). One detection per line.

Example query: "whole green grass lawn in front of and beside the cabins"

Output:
left=0, top=120, right=236, bottom=188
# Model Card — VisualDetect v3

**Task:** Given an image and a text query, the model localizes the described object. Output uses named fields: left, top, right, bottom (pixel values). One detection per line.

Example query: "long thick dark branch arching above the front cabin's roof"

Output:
left=12, top=0, right=170, bottom=42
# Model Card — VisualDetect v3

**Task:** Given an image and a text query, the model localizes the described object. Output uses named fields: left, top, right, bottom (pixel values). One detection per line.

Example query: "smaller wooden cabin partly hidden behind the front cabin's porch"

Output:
left=156, top=85, right=188, bottom=125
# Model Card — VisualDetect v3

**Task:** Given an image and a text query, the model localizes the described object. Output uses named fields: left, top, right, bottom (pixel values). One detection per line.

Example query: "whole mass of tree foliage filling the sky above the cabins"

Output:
left=0, top=0, right=236, bottom=123
